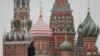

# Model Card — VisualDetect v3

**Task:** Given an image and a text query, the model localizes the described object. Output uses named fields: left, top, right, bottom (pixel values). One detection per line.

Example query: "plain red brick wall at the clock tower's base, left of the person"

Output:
left=3, top=44, right=29, bottom=56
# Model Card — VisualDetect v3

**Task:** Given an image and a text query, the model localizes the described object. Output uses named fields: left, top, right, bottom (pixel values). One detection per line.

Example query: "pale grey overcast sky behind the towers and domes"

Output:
left=0, top=0, right=100, bottom=56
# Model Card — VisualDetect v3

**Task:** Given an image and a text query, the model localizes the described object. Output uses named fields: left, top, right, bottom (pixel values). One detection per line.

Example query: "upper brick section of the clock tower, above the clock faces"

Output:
left=14, top=0, right=30, bottom=19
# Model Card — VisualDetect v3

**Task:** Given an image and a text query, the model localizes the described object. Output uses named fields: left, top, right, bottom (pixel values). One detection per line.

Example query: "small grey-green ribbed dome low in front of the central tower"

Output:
left=60, top=40, right=72, bottom=51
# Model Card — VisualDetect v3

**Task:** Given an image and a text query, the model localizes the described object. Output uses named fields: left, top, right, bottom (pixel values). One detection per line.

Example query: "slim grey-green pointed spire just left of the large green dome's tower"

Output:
left=73, top=25, right=86, bottom=56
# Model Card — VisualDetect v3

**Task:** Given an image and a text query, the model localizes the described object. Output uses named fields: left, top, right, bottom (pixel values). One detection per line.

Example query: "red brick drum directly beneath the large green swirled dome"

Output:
left=83, top=37, right=97, bottom=52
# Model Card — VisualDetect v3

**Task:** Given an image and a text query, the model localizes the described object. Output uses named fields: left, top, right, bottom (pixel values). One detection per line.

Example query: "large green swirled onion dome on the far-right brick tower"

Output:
left=80, top=12, right=99, bottom=37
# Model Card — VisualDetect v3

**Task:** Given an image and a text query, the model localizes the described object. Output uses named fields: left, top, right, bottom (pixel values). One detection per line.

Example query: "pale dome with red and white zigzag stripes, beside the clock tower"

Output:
left=30, top=7, right=52, bottom=36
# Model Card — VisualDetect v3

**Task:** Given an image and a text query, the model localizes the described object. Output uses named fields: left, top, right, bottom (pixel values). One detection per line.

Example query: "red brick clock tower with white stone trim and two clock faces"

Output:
left=3, top=0, right=32, bottom=56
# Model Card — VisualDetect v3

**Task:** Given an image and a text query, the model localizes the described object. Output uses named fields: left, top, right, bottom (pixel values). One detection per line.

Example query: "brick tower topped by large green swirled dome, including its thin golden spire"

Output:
left=80, top=0, right=100, bottom=56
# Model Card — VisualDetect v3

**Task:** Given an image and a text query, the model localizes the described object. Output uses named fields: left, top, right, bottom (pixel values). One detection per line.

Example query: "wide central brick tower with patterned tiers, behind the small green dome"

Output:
left=50, top=0, right=75, bottom=55
